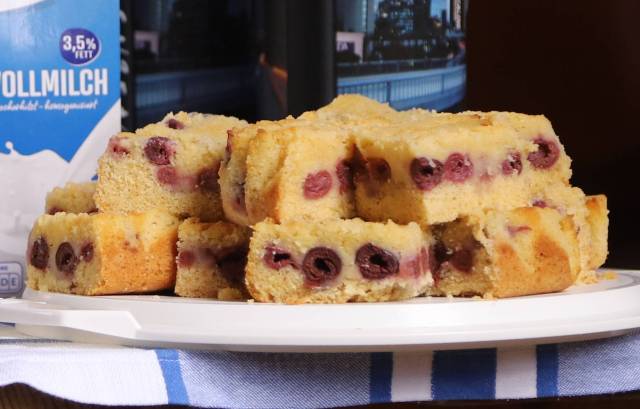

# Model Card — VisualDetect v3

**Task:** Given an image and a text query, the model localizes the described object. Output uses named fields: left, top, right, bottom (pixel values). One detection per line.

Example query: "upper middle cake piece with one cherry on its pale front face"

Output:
left=245, top=123, right=355, bottom=224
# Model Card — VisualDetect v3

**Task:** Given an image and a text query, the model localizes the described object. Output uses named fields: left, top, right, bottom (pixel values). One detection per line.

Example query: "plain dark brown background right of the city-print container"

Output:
left=466, top=0, right=640, bottom=268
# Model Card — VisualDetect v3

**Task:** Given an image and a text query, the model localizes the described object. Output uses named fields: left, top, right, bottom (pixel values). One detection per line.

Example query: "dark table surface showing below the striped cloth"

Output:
left=0, top=384, right=640, bottom=409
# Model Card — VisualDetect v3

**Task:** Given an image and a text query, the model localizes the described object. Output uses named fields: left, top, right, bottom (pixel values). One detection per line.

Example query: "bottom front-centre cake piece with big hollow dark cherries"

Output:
left=246, top=219, right=433, bottom=304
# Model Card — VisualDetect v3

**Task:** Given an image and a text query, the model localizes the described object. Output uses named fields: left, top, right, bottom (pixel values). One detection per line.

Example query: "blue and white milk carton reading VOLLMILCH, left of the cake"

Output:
left=0, top=0, right=120, bottom=296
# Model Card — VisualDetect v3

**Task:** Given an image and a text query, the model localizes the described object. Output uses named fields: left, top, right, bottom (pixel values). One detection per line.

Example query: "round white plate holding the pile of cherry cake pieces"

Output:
left=0, top=270, right=640, bottom=352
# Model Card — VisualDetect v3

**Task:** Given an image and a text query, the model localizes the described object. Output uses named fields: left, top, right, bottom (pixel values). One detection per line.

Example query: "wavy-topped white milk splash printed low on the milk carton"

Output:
left=0, top=142, right=69, bottom=256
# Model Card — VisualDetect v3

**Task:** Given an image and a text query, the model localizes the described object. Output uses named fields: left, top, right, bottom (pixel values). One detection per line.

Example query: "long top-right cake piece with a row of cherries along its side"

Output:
left=352, top=112, right=571, bottom=227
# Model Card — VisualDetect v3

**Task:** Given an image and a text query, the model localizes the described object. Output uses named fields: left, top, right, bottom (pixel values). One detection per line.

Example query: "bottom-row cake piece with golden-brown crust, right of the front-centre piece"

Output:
left=432, top=207, right=580, bottom=298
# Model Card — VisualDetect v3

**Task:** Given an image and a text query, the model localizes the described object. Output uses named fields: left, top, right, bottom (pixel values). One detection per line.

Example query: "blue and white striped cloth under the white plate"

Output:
left=0, top=326, right=640, bottom=408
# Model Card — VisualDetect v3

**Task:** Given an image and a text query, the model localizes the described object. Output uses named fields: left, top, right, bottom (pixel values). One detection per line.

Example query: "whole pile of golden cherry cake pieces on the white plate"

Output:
left=27, top=95, right=608, bottom=304
